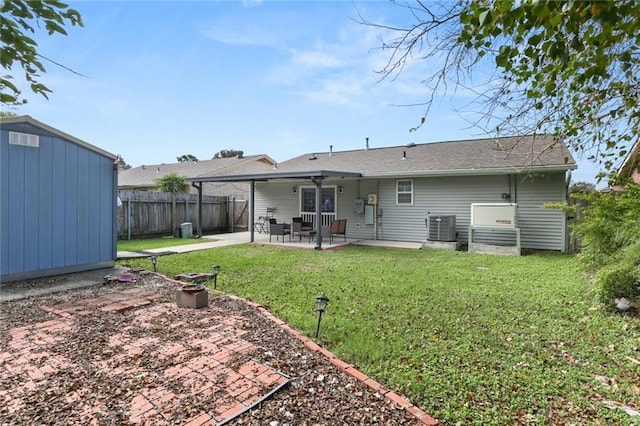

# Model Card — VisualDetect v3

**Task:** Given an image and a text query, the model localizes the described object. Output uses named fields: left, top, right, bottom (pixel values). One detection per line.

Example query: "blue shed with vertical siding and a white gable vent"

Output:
left=0, top=116, right=118, bottom=284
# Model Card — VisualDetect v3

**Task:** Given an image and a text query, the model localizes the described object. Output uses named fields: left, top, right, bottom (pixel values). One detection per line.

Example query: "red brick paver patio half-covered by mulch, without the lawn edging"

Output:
left=0, top=288, right=288, bottom=426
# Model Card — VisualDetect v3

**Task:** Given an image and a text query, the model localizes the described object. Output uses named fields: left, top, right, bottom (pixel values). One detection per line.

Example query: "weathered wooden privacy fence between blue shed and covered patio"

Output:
left=118, top=191, right=248, bottom=239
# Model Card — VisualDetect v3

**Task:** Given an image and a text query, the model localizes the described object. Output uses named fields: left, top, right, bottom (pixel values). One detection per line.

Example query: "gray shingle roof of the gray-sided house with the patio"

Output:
left=185, top=136, right=577, bottom=182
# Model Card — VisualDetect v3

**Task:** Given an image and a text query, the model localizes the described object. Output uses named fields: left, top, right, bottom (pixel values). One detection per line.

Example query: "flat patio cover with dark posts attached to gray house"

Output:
left=185, top=170, right=362, bottom=250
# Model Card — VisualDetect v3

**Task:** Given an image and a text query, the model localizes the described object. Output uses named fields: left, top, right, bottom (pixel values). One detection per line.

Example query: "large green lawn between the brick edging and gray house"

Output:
left=116, top=245, right=640, bottom=424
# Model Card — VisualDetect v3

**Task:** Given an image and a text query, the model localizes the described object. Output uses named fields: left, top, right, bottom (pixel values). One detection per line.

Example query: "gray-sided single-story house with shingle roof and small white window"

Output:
left=188, top=136, right=576, bottom=251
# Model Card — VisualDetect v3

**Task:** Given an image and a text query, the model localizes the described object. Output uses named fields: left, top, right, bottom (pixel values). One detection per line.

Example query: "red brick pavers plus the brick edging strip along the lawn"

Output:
left=0, top=288, right=438, bottom=426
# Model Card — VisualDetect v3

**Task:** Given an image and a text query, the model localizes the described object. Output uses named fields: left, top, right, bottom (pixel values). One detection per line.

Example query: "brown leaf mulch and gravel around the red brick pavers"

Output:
left=0, top=275, right=420, bottom=426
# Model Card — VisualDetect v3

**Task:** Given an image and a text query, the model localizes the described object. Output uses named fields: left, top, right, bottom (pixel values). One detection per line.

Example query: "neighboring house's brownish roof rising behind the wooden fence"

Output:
left=118, top=154, right=275, bottom=188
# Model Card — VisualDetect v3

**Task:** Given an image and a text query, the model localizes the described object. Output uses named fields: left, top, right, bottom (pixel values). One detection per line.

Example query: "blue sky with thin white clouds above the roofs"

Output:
left=8, top=0, right=597, bottom=182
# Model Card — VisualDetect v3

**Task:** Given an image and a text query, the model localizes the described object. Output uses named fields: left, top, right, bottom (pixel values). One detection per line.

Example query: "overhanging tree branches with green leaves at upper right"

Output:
left=376, top=0, right=640, bottom=174
